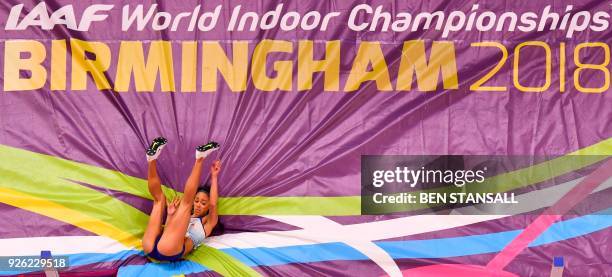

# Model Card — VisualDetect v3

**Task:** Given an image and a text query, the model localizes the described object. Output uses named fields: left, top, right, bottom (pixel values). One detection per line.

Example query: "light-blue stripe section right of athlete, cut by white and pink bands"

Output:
left=222, top=209, right=612, bottom=266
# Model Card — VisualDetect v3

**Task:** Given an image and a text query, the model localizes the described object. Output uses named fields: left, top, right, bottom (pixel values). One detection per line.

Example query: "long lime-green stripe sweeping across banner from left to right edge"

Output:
left=0, top=138, right=612, bottom=216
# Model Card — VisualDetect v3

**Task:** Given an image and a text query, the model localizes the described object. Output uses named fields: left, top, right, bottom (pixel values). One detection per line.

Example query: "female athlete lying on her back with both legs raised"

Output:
left=142, top=137, right=221, bottom=261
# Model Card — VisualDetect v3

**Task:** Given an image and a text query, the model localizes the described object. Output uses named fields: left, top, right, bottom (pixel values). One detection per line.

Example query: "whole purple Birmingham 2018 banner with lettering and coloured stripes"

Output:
left=0, top=0, right=612, bottom=276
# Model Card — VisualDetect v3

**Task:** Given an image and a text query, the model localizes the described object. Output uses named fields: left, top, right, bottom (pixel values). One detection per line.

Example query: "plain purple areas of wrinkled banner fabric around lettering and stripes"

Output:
left=0, top=0, right=612, bottom=276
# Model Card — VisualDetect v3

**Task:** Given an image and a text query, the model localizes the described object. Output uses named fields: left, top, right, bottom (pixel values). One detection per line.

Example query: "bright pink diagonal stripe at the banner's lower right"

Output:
left=487, top=159, right=612, bottom=270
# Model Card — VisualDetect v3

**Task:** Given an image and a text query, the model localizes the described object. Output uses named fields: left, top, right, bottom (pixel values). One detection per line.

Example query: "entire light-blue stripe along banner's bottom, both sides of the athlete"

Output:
left=0, top=208, right=612, bottom=276
